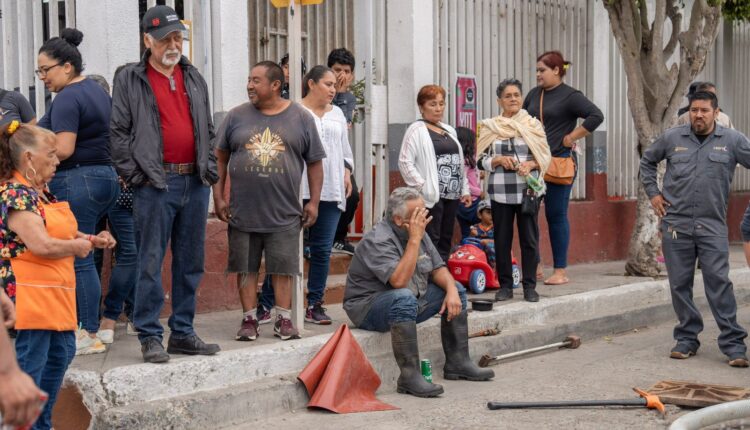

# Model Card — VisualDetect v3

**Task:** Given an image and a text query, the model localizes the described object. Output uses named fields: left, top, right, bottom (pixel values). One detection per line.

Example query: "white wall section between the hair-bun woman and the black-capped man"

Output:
left=76, top=0, right=140, bottom=85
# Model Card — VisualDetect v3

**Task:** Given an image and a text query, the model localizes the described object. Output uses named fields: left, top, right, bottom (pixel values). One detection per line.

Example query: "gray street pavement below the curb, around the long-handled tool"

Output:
left=251, top=306, right=750, bottom=430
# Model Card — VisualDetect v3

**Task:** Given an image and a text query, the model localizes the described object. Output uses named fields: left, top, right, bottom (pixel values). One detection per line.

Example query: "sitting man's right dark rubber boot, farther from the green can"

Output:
left=440, top=310, right=495, bottom=381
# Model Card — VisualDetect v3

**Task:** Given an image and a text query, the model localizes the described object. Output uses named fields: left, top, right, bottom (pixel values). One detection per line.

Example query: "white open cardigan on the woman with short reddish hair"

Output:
left=398, top=121, right=469, bottom=208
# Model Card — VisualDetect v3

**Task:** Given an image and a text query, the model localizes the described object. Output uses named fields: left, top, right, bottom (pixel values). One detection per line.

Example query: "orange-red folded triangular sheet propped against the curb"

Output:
left=297, top=324, right=398, bottom=414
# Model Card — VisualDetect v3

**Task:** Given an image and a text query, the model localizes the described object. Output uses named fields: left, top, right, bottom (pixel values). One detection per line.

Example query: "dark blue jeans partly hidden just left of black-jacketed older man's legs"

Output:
left=103, top=205, right=138, bottom=321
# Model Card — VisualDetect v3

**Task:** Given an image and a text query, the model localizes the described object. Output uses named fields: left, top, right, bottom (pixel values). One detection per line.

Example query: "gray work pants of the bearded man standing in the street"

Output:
left=662, top=228, right=747, bottom=356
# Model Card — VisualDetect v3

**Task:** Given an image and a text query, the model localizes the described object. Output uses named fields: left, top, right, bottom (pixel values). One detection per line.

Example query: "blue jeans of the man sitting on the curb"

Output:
left=359, top=282, right=466, bottom=332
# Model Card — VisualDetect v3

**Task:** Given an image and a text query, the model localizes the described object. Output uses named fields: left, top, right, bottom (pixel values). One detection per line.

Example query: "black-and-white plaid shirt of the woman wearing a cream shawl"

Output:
left=477, top=137, right=539, bottom=205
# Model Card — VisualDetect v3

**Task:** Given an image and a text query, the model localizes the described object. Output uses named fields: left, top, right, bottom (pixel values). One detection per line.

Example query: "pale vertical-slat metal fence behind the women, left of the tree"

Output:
left=434, top=0, right=588, bottom=199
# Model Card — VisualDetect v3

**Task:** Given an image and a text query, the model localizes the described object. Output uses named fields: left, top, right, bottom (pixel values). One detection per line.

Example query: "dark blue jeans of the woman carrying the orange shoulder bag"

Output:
left=544, top=182, right=573, bottom=269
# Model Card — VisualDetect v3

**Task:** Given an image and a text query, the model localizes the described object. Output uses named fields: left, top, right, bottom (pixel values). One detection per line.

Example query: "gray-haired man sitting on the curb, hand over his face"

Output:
left=344, top=187, right=495, bottom=397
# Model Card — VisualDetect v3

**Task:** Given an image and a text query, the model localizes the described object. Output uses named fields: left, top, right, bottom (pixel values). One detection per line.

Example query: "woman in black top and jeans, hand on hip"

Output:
left=523, top=51, right=604, bottom=285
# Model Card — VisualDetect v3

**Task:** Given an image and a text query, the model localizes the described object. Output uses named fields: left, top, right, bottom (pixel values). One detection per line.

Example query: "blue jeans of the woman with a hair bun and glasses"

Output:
left=49, top=166, right=120, bottom=333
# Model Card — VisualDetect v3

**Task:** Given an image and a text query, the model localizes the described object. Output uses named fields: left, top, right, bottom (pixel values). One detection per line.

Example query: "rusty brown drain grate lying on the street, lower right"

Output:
left=648, top=381, right=750, bottom=408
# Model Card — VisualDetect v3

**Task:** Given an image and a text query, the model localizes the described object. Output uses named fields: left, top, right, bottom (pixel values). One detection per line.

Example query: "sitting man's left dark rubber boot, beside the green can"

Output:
left=391, top=321, right=443, bottom=397
